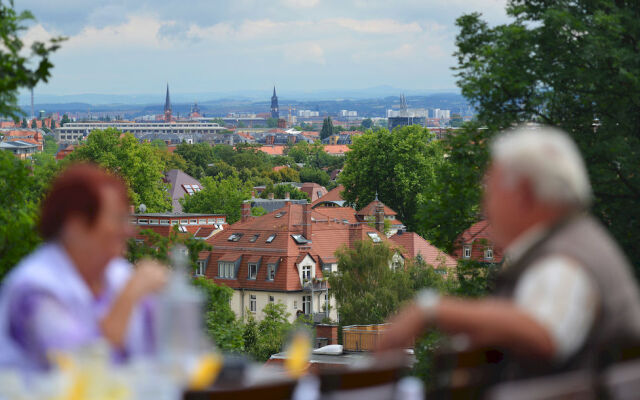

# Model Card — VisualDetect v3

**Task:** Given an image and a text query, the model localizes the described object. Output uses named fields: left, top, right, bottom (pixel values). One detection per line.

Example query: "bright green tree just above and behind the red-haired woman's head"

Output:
left=69, top=128, right=171, bottom=212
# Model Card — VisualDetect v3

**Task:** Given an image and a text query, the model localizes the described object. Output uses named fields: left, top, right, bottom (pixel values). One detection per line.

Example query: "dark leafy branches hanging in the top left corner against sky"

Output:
left=0, top=0, right=64, bottom=118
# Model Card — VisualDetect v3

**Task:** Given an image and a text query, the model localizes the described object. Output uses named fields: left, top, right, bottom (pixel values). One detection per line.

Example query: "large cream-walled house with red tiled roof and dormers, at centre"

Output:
left=204, top=203, right=403, bottom=321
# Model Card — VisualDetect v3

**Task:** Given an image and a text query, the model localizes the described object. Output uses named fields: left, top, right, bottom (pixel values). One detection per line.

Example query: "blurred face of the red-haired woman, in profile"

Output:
left=86, top=186, right=133, bottom=263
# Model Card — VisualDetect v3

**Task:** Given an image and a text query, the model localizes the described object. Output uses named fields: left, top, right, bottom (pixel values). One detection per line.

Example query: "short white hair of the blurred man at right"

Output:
left=491, top=125, right=591, bottom=208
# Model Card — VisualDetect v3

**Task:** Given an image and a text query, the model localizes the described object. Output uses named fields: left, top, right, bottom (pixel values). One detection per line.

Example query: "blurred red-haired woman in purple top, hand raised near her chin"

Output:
left=0, top=164, right=167, bottom=372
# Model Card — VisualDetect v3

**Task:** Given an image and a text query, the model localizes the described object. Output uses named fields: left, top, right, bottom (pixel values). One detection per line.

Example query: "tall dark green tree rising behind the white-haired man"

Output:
left=456, top=0, right=640, bottom=272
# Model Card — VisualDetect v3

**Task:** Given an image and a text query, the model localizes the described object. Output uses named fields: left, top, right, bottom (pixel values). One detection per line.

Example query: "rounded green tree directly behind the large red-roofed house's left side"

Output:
left=181, top=175, right=252, bottom=224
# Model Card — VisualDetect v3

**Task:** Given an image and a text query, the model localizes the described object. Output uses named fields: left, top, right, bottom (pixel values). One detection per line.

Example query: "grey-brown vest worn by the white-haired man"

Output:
left=494, top=214, right=640, bottom=378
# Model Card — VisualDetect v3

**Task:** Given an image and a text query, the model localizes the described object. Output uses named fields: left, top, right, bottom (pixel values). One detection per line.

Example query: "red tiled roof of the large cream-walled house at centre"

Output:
left=206, top=204, right=396, bottom=291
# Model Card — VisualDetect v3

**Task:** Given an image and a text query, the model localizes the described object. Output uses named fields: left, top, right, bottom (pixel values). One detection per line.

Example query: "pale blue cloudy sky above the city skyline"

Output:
left=15, top=0, right=507, bottom=95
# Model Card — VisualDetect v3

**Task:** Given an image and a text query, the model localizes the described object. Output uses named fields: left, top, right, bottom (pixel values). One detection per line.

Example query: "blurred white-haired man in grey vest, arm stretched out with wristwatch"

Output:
left=380, top=127, right=640, bottom=378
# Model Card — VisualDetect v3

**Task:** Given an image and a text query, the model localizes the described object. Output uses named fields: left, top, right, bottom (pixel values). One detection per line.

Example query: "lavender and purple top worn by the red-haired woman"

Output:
left=0, top=243, right=153, bottom=373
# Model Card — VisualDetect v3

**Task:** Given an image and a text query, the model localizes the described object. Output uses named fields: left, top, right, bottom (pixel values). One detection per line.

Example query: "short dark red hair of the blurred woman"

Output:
left=40, top=163, right=129, bottom=240
